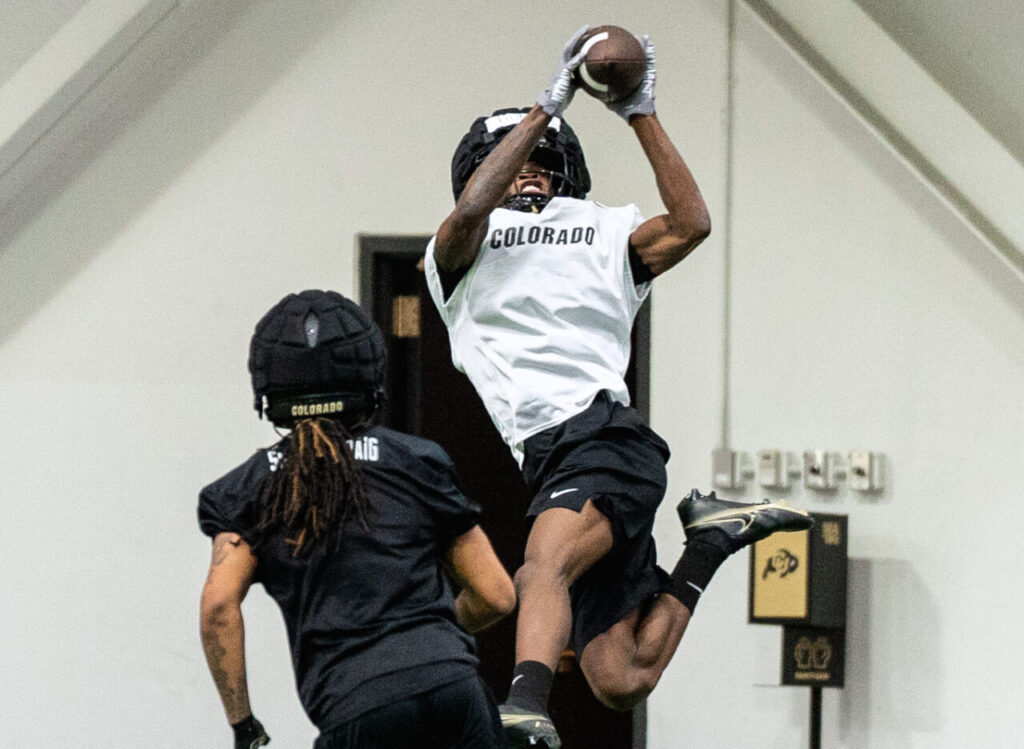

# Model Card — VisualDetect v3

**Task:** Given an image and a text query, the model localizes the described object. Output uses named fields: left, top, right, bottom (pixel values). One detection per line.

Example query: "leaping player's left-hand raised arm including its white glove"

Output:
left=434, top=26, right=590, bottom=272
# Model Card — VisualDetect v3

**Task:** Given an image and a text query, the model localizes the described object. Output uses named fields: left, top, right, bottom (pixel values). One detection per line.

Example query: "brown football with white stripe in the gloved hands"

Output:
left=575, top=26, right=647, bottom=101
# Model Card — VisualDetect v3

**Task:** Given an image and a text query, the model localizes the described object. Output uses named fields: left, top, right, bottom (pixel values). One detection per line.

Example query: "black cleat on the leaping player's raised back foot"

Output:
left=676, top=489, right=814, bottom=553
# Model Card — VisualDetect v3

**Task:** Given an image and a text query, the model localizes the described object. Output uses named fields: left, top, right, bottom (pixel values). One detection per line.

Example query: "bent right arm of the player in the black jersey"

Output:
left=445, top=526, right=516, bottom=632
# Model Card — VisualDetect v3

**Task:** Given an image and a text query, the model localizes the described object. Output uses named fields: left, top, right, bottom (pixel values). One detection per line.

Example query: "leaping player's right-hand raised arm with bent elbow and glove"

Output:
left=608, top=36, right=711, bottom=276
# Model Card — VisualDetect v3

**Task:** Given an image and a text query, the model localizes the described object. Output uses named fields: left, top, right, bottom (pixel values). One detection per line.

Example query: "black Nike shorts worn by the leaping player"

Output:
left=522, top=392, right=670, bottom=657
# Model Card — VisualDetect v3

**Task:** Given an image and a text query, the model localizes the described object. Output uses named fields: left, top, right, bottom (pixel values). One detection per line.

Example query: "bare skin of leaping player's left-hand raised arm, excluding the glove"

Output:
left=434, top=106, right=551, bottom=271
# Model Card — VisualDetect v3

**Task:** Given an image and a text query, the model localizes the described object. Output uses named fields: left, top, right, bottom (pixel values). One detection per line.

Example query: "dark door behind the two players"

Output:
left=359, top=237, right=648, bottom=749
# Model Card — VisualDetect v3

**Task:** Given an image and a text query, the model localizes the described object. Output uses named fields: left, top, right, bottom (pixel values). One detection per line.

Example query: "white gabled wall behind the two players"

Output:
left=0, top=0, right=1024, bottom=749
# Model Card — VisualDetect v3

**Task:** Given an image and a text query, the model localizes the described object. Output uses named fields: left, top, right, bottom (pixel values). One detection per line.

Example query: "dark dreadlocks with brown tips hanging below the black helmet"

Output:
left=254, top=418, right=370, bottom=556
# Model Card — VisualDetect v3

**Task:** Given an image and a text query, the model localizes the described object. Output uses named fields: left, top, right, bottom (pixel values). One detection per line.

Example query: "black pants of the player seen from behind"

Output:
left=313, top=676, right=506, bottom=749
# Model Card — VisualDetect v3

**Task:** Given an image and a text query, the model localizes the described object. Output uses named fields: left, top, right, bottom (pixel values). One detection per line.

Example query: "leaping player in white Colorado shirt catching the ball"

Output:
left=425, top=28, right=811, bottom=747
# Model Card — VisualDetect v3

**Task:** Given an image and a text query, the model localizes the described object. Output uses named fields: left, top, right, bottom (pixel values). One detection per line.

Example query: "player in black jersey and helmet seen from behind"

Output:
left=199, top=291, right=516, bottom=749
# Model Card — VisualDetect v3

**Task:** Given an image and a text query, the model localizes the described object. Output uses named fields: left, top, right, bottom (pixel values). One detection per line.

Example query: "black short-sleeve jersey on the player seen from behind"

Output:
left=199, top=426, right=480, bottom=731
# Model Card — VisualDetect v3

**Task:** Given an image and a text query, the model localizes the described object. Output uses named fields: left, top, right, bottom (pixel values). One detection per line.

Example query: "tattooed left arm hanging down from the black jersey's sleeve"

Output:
left=200, top=533, right=256, bottom=723
